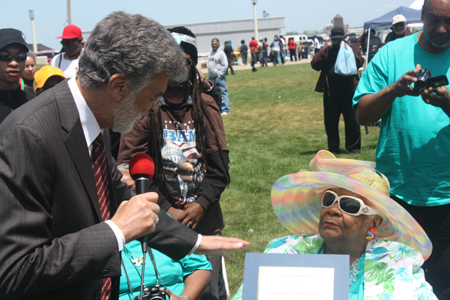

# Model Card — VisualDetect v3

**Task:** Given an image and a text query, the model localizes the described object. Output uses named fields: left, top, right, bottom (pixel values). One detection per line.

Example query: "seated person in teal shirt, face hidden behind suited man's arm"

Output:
left=119, top=241, right=212, bottom=300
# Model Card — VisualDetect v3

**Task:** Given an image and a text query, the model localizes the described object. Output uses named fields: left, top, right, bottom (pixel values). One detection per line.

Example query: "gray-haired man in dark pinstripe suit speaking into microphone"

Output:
left=0, top=12, right=248, bottom=300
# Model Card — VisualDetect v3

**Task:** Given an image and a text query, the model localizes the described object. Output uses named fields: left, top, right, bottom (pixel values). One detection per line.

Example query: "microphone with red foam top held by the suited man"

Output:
left=129, top=153, right=155, bottom=195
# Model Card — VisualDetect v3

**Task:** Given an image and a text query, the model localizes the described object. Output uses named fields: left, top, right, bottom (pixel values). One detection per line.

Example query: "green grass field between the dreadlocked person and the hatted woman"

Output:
left=217, top=64, right=379, bottom=295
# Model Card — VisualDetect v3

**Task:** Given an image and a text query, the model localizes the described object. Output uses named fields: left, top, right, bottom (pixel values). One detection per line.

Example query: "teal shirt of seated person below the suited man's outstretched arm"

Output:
left=119, top=241, right=212, bottom=300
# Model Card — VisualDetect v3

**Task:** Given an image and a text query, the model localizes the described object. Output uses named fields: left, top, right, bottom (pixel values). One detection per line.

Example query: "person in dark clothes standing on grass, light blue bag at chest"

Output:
left=311, top=26, right=364, bottom=154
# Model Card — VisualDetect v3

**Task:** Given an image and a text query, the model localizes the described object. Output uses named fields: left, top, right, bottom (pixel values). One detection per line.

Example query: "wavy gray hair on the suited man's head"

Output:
left=77, top=12, right=188, bottom=93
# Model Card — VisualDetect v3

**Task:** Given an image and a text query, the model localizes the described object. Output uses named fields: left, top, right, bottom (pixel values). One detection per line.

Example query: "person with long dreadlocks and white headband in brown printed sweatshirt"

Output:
left=118, top=27, right=230, bottom=300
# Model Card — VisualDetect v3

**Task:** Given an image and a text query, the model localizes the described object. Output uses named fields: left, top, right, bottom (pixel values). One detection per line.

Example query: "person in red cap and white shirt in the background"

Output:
left=50, top=25, right=83, bottom=78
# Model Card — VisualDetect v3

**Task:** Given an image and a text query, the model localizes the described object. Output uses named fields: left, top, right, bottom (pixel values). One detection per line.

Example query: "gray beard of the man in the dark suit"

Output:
left=112, top=95, right=148, bottom=133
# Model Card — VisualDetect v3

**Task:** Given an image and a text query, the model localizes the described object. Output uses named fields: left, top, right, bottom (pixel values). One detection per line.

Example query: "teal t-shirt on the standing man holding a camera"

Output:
left=353, top=34, right=450, bottom=206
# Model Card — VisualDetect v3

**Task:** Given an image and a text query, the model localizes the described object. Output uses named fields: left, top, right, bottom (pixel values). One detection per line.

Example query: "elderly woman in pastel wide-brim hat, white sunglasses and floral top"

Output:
left=232, top=150, right=437, bottom=300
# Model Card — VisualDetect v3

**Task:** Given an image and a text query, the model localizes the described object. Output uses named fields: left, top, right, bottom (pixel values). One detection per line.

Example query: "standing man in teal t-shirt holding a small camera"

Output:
left=353, top=0, right=450, bottom=299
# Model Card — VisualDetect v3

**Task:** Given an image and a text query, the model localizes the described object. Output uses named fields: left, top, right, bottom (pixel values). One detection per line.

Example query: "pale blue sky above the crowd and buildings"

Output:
left=0, top=0, right=414, bottom=50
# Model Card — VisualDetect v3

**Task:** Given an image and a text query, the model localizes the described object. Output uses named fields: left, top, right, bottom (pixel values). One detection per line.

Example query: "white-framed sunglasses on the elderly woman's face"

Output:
left=321, top=191, right=377, bottom=217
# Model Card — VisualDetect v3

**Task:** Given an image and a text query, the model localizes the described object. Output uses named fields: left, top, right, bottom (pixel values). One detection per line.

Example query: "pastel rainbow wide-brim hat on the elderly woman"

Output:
left=272, top=150, right=432, bottom=260
